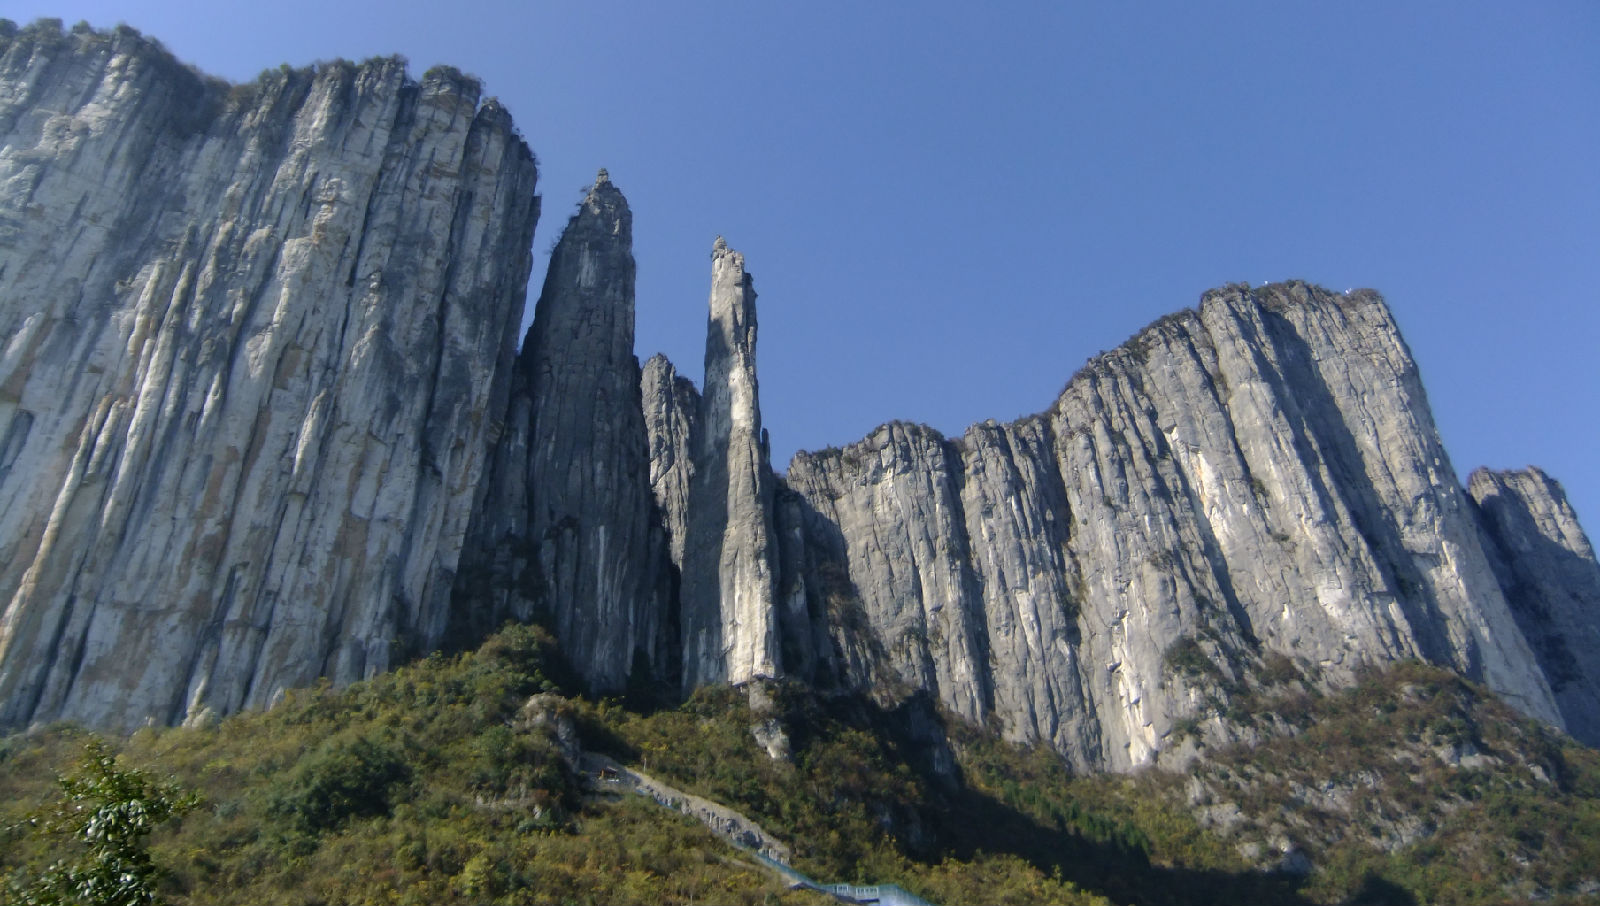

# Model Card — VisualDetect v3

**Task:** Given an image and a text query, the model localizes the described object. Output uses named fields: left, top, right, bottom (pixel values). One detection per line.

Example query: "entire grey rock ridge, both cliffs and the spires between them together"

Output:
left=0, top=26, right=1600, bottom=770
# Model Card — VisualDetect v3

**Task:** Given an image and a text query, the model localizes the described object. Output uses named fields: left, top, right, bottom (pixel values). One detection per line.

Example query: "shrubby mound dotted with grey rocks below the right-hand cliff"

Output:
left=1149, top=663, right=1600, bottom=903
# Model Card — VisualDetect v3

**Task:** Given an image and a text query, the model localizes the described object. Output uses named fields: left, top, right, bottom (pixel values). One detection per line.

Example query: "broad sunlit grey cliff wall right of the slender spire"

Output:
left=787, top=283, right=1560, bottom=768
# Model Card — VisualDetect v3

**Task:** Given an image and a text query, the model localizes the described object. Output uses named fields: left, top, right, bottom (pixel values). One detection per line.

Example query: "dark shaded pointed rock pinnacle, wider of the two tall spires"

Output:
left=458, top=170, right=664, bottom=692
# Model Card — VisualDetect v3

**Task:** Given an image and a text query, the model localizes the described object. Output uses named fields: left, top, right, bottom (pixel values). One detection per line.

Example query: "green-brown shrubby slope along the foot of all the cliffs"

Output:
left=0, top=626, right=1600, bottom=903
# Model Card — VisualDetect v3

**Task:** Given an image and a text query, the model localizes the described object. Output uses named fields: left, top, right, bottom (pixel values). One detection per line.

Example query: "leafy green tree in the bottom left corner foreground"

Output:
left=11, top=738, right=200, bottom=906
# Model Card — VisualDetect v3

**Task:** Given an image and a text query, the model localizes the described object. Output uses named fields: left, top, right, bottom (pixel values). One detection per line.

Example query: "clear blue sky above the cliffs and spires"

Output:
left=12, top=0, right=1600, bottom=535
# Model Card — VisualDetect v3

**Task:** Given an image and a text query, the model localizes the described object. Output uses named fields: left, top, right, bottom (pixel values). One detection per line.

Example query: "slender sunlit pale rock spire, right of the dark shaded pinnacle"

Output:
left=680, top=237, right=778, bottom=688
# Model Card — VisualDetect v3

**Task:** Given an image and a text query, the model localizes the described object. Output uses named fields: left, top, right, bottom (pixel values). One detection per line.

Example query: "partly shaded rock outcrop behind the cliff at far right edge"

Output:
left=1467, top=469, right=1600, bottom=746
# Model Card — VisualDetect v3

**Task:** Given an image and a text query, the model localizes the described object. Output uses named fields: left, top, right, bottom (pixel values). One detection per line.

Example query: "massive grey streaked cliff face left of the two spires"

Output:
left=0, top=26, right=536, bottom=727
